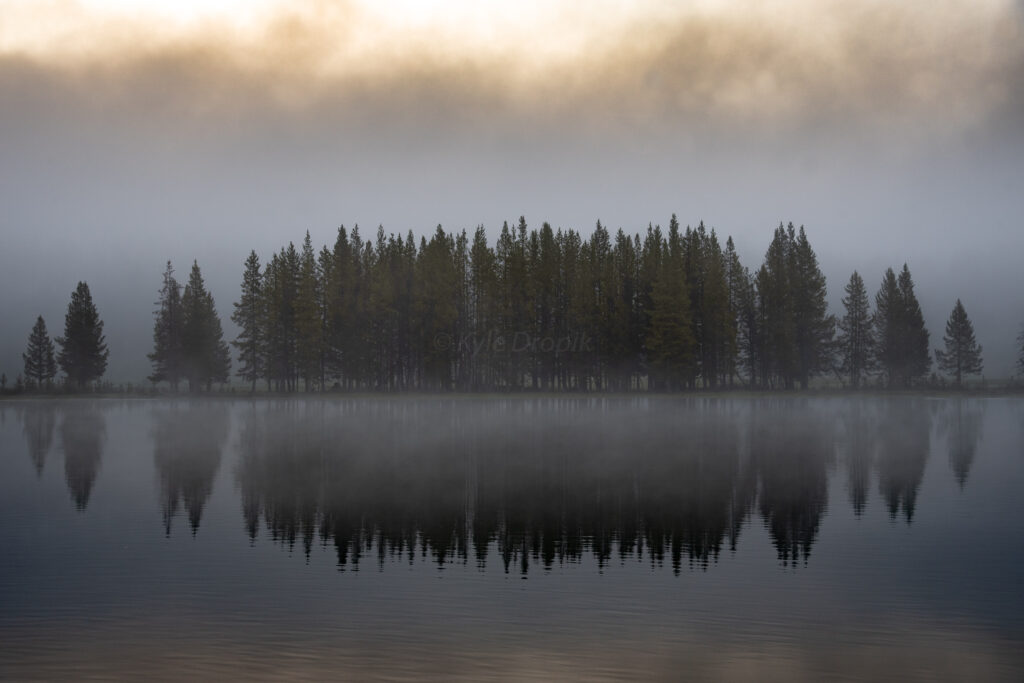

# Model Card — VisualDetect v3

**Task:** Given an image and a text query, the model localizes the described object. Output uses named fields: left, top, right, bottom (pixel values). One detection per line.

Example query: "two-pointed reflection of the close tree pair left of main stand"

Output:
left=153, top=401, right=229, bottom=537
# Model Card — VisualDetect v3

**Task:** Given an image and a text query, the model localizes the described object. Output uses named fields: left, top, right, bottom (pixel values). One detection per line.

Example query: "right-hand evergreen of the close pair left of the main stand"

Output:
left=181, top=261, right=231, bottom=391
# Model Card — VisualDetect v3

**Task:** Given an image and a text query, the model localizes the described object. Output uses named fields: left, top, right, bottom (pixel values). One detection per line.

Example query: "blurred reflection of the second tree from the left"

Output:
left=59, top=401, right=106, bottom=511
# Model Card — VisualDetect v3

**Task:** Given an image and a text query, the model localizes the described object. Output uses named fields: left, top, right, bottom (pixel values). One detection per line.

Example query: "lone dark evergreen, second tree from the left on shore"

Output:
left=56, top=283, right=109, bottom=389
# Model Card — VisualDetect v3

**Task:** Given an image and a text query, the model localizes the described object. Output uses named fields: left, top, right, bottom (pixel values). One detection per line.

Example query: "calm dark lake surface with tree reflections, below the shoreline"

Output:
left=0, top=397, right=1024, bottom=681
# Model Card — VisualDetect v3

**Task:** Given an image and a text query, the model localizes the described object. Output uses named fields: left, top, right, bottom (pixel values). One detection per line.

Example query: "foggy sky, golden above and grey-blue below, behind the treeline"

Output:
left=0, top=0, right=1024, bottom=381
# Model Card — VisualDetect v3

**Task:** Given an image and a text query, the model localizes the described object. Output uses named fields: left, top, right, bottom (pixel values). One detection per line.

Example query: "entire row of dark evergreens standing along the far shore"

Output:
left=8, top=216, right=1024, bottom=392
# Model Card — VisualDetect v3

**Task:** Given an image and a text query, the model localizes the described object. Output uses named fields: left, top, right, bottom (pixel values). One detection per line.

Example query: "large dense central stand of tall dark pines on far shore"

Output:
left=231, top=216, right=835, bottom=391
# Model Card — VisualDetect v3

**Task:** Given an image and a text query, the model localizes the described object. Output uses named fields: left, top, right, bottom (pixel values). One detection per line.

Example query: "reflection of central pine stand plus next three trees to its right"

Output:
left=230, top=399, right=932, bottom=573
